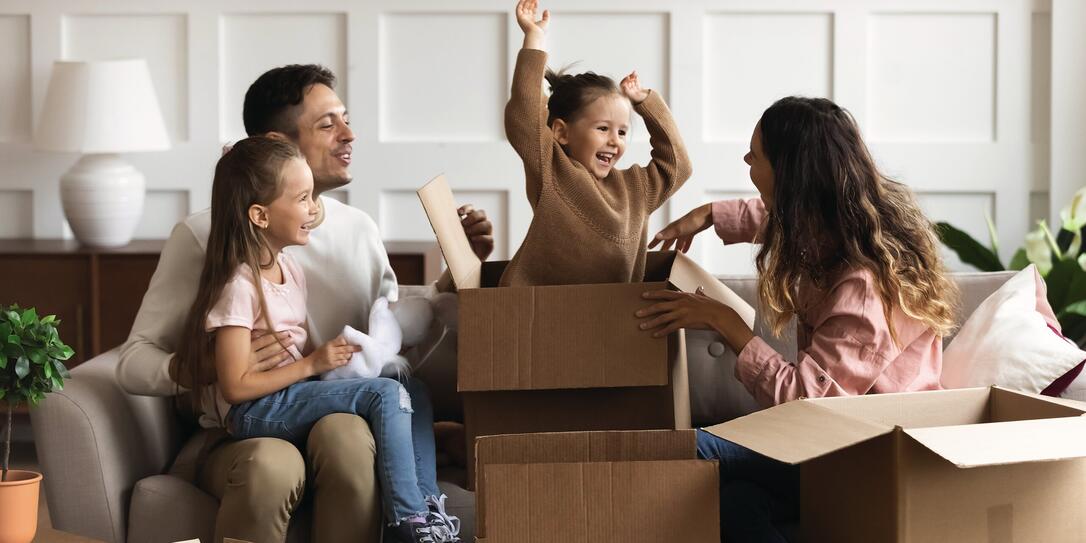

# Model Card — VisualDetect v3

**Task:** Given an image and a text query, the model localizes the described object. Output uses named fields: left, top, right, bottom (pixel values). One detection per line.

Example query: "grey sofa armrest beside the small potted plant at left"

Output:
left=30, top=350, right=180, bottom=543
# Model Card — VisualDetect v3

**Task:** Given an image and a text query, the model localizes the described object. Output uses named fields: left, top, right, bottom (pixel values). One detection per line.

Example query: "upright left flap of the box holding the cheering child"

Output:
left=417, top=175, right=482, bottom=289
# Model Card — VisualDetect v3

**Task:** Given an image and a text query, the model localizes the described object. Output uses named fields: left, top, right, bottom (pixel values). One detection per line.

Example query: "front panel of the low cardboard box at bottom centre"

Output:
left=483, top=460, right=720, bottom=543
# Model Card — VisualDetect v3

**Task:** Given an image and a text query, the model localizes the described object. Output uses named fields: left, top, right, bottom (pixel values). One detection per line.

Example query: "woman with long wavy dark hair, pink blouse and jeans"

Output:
left=637, top=97, right=958, bottom=542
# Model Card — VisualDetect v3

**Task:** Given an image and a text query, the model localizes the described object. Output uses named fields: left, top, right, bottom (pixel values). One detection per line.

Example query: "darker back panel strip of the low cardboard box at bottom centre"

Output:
left=476, top=430, right=697, bottom=536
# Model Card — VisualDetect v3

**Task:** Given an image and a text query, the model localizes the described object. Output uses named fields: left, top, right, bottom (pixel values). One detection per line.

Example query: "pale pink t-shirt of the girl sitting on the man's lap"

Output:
left=206, top=252, right=308, bottom=366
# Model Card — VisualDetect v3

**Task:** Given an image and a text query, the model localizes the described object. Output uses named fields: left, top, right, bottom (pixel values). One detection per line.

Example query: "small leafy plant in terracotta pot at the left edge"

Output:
left=0, top=305, right=73, bottom=543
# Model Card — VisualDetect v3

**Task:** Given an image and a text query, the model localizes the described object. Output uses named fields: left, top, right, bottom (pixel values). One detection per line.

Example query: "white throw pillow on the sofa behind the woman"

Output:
left=942, top=265, right=1086, bottom=393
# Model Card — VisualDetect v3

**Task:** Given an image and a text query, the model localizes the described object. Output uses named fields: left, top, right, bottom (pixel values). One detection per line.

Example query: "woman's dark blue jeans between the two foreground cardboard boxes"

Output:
left=697, top=430, right=799, bottom=543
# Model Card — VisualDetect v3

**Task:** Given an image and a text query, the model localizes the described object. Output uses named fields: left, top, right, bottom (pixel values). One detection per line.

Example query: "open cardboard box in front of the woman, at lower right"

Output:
left=707, top=387, right=1086, bottom=543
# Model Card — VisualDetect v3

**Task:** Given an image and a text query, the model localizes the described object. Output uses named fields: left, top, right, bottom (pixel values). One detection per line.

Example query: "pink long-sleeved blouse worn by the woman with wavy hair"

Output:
left=712, top=198, right=943, bottom=406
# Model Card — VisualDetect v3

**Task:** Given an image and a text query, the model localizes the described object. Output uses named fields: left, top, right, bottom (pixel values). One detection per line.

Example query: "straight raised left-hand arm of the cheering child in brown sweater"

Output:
left=505, top=0, right=554, bottom=207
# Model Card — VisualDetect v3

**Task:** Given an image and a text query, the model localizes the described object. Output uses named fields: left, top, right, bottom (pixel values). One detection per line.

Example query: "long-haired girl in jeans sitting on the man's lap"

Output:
left=172, top=137, right=459, bottom=542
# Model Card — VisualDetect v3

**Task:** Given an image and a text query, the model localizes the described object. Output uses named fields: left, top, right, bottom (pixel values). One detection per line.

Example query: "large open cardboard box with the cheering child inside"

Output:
left=418, top=176, right=754, bottom=487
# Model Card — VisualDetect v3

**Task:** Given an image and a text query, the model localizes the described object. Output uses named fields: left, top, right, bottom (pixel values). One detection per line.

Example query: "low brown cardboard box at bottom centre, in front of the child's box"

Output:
left=476, top=430, right=720, bottom=543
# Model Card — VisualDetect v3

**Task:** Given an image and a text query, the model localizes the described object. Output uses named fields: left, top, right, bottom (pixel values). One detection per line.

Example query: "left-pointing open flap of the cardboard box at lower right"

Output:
left=705, top=400, right=895, bottom=464
